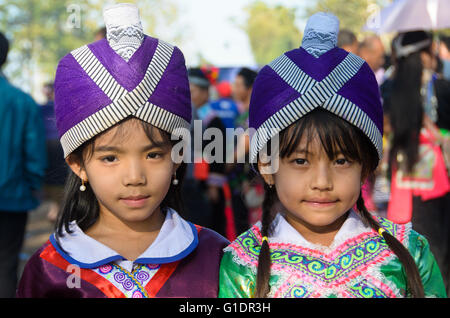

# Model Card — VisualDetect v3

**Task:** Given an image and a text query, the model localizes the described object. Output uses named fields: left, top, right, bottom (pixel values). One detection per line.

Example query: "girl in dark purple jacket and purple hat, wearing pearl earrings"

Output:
left=17, top=5, right=227, bottom=298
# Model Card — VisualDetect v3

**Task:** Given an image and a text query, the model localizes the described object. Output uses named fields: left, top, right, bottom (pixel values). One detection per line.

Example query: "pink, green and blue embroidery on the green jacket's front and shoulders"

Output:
left=230, top=219, right=404, bottom=298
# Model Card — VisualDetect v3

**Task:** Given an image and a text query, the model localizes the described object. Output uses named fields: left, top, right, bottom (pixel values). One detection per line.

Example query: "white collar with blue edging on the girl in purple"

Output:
left=50, top=209, right=198, bottom=268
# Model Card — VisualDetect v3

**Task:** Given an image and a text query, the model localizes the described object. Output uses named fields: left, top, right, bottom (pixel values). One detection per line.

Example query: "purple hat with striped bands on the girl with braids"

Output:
left=249, top=12, right=383, bottom=163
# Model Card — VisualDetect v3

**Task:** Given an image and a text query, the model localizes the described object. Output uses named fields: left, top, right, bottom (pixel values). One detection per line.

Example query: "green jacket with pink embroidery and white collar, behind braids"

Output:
left=219, top=211, right=446, bottom=298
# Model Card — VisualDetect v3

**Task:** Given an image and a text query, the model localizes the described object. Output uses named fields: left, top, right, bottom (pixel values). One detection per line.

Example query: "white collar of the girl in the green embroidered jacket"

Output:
left=268, top=210, right=371, bottom=253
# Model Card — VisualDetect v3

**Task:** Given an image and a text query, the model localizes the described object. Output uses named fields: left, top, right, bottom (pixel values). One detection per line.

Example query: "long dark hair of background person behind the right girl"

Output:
left=386, top=31, right=432, bottom=175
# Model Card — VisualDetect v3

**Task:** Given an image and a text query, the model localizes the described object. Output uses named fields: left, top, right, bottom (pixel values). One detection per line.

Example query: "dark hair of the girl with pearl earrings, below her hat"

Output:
left=55, top=118, right=186, bottom=237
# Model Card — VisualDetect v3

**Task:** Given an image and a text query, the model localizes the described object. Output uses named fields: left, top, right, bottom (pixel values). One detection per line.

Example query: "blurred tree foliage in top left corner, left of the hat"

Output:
left=0, top=0, right=91, bottom=90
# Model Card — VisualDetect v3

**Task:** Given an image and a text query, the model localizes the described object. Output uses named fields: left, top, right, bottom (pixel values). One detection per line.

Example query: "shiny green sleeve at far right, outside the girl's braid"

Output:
left=409, top=231, right=447, bottom=298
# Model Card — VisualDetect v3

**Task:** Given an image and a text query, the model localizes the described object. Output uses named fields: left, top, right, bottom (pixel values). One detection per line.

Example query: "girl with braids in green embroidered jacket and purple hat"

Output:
left=219, top=13, right=445, bottom=297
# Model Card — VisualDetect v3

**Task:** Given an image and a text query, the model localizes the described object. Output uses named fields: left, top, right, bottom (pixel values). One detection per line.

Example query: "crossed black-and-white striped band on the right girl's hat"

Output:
left=250, top=53, right=383, bottom=163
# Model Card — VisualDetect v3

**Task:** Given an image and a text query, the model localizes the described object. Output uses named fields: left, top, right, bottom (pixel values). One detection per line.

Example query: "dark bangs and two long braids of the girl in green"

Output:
left=254, top=108, right=424, bottom=298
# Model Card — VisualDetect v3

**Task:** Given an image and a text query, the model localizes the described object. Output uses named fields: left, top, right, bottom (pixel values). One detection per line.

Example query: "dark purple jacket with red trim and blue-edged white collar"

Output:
left=17, top=209, right=228, bottom=298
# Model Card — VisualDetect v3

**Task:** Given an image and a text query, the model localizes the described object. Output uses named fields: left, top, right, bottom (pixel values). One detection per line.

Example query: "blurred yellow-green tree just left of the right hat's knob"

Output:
left=241, top=1, right=301, bottom=65
